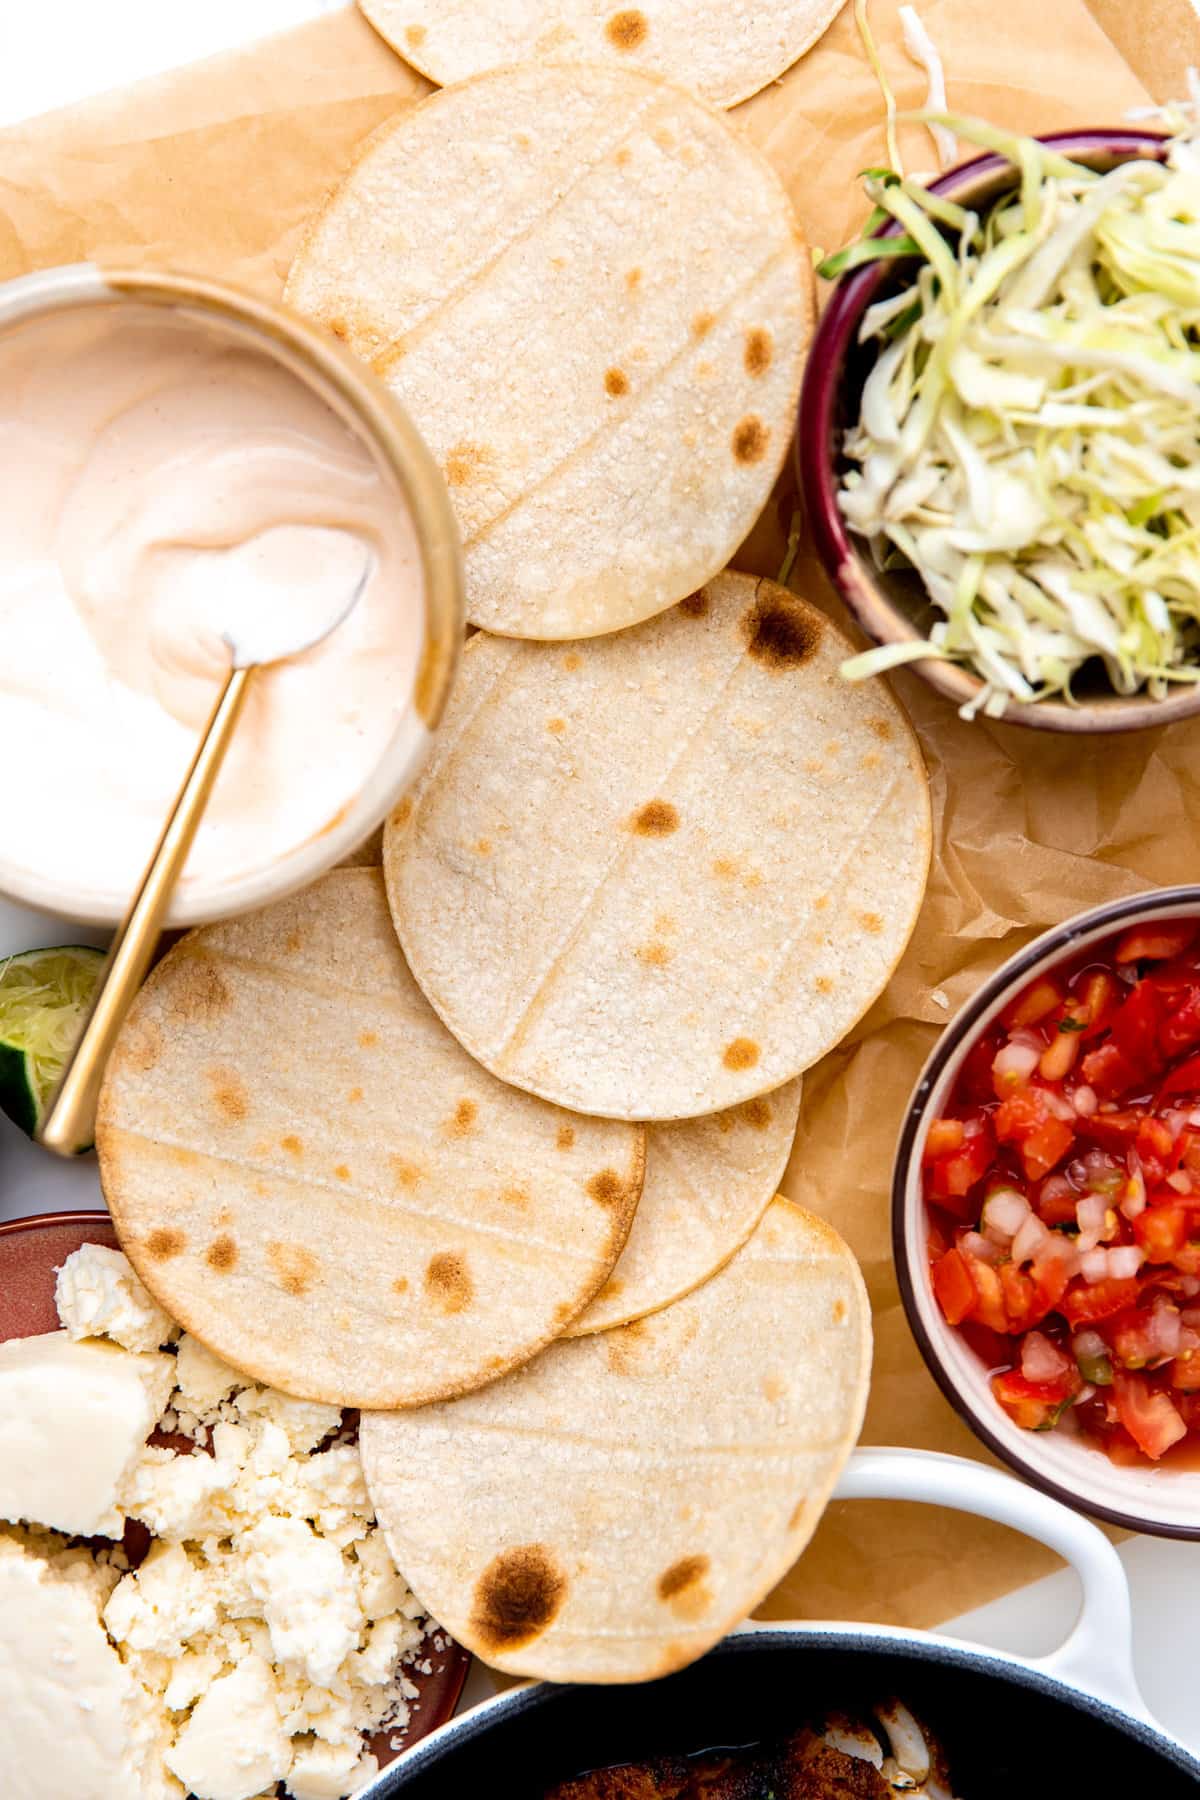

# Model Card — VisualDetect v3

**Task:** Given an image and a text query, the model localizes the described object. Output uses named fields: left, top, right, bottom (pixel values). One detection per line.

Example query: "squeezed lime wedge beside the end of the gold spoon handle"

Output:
left=0, top=943, right=104, bottom=1138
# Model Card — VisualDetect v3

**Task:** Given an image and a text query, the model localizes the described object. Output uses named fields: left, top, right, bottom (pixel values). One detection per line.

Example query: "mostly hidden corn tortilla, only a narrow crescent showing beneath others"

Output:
left=565, top=1076, right=802, bottom=1337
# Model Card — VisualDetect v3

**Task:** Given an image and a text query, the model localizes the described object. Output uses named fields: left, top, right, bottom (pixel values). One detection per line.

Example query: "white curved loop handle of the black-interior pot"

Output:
left=833, top=1449, right=1155, bottom=1724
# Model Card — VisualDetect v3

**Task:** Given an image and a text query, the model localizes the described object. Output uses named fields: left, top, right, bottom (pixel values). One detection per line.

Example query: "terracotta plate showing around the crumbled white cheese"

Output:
left=0, top=1213, right=471, bottom=1768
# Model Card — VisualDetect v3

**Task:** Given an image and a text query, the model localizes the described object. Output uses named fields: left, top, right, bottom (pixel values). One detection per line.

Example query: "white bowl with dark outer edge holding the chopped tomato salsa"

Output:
left=892, top=887, right=1200, bottom=1539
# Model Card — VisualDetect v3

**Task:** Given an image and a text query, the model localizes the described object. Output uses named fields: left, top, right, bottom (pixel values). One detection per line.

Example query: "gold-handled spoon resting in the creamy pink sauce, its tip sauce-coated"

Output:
left=36, top=549, right=374, bottom=1156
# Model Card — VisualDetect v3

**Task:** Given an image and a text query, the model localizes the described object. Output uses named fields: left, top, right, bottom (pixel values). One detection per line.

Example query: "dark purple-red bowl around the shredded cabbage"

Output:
left=795, top=131, right=1180, bottom=733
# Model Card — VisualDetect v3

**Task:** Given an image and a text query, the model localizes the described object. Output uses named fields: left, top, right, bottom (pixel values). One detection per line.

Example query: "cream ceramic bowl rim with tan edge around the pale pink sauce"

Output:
left=0, top=263, right=462, bottom=925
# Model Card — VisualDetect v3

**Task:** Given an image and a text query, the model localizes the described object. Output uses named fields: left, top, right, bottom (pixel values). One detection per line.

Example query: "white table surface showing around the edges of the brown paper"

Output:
left=0, top=0, right=1200, bottom=1753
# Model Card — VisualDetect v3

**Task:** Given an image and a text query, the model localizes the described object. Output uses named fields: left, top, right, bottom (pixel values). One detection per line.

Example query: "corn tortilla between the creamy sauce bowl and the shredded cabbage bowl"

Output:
left=286, top=67, right=813, bottom=639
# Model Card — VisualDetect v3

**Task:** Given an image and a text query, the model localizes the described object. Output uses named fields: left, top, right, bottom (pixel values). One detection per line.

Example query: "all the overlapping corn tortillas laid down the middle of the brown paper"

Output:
left=97, top=38, right=930, bottom=1681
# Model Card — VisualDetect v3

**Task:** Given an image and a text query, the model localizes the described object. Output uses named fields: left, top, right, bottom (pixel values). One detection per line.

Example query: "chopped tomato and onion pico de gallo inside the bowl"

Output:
left=923, top=920, right=1200, bottom=1463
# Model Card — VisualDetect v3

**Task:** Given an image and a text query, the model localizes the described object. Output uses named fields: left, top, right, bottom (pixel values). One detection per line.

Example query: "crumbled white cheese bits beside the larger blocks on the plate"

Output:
left=0, top=1246, right=426, bottom=1800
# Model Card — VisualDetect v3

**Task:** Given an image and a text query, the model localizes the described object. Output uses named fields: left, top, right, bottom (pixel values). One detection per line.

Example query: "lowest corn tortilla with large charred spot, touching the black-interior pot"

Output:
left=360, top=1199, right=871, bottom=1681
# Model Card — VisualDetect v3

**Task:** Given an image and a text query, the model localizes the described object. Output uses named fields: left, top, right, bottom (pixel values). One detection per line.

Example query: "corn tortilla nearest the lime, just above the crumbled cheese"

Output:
left=95, top=869, right=644, bottom=1406
